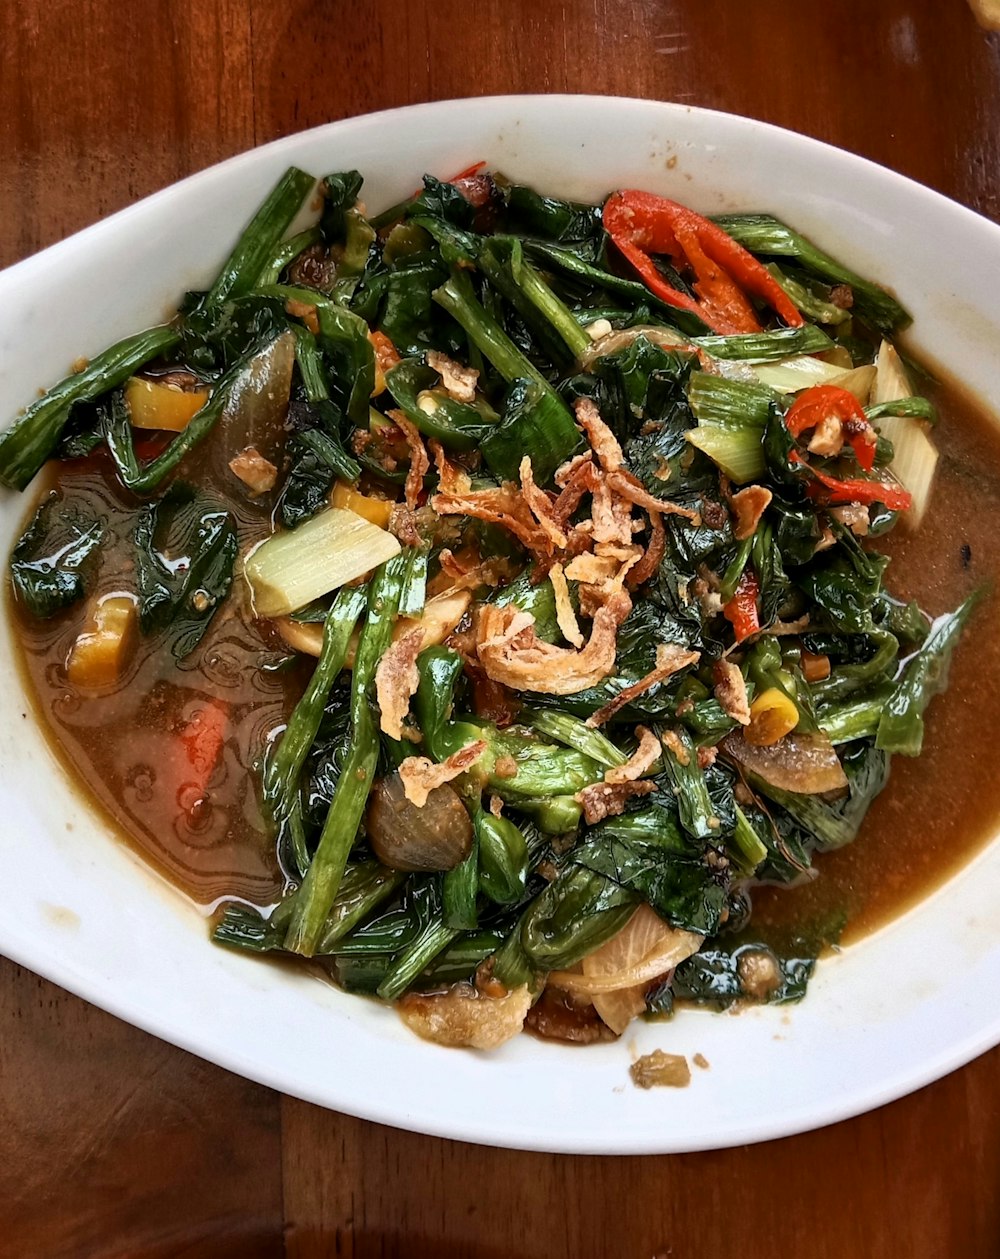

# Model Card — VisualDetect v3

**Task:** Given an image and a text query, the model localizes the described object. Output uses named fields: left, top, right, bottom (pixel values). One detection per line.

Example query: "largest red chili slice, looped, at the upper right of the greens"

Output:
left=605, top=189, right=802, bottom=336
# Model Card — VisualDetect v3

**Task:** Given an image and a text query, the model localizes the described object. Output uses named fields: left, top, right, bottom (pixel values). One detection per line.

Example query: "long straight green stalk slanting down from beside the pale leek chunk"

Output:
left=285, top=554, right=407, bottom=957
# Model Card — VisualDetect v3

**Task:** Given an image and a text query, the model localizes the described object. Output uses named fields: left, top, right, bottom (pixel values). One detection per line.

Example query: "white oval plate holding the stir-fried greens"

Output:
left=0, top=96, right=1000, bottom=1153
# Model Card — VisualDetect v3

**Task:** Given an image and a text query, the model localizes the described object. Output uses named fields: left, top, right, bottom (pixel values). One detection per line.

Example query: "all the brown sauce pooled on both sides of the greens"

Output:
left=6, top=365, right=1000, bottom=940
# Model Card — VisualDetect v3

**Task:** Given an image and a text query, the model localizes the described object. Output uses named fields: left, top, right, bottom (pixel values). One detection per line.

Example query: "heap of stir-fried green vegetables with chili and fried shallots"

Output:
left=0, top=165, right=975, bottom=1049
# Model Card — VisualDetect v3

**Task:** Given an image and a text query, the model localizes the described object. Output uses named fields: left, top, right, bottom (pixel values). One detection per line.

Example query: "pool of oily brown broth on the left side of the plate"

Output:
left=6, top=456, right=299, bottom=905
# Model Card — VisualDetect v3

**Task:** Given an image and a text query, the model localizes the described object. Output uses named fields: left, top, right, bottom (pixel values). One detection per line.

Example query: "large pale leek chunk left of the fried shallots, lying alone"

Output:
left=243, top=507, right=402, bottom=617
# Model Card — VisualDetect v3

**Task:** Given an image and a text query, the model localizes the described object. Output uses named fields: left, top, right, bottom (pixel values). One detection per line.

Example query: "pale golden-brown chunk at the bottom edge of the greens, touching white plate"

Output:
left=397, top=983, right=531, bottom=1049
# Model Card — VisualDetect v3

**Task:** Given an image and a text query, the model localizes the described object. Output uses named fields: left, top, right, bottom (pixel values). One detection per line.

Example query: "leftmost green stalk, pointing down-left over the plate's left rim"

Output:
left=0, top=327, right=180, bottom=490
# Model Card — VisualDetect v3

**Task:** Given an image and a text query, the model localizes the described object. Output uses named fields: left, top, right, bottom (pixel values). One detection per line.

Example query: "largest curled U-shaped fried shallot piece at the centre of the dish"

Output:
left=476, top=588, right=632, bottom=695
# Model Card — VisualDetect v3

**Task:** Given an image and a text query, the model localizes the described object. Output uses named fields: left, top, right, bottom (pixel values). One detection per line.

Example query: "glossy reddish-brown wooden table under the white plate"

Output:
left=0, top=0, right=1000, bottom=1259
